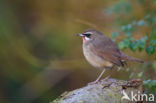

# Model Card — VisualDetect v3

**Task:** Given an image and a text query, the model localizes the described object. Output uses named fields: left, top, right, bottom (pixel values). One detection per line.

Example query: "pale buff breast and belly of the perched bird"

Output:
left=83, top=44, right=113, bottom=68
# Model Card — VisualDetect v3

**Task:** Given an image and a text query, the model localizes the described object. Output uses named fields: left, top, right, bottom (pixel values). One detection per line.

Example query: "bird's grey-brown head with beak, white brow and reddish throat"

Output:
left=77, top=29, right=101, bottom=43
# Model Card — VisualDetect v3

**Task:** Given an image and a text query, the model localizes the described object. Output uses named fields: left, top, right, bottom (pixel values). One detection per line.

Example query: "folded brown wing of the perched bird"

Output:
left=92, top=36, right=124, bottom=66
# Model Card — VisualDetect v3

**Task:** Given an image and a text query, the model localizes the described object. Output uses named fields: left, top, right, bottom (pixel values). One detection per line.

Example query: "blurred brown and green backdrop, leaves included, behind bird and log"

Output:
left=0, top=0, right=156, bottom=103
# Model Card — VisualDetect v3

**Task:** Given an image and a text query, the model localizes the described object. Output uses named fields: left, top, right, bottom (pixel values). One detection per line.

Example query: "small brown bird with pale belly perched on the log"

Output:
left=77, top=29, right=143, bottom=83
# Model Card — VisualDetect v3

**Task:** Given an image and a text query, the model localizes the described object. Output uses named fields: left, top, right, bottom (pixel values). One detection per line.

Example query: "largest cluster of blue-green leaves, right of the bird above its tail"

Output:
left=112, top=14, right=156, bottom=55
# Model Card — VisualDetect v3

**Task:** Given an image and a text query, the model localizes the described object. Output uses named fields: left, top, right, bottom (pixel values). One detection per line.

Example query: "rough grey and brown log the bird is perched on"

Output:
left=51, top=79, right=143, bottom=103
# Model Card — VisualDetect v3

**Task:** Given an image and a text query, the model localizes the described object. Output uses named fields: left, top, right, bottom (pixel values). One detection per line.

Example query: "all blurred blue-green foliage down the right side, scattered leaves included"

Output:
left=108, top=0, right=156, bottom=95
